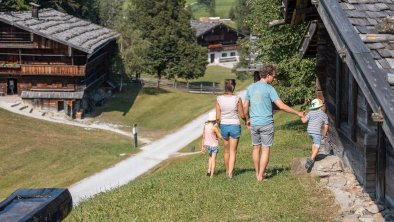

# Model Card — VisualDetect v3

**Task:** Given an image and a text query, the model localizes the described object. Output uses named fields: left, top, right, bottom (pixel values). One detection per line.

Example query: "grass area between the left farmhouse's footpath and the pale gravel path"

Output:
left=0, top=109, right=137, bottom=200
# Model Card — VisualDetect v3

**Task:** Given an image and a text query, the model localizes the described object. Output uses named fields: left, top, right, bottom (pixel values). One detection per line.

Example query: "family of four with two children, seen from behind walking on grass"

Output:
left=201, top=65, right=328, bottom=181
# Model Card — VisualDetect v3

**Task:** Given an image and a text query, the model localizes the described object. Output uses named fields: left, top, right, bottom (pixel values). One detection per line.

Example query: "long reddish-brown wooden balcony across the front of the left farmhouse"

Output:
left=0, top=65, right=85, bottom=76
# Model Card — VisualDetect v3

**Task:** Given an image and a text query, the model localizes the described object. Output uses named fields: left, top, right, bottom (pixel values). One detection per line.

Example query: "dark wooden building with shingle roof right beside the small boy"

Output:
left=282, top=0, right=394, bottom=206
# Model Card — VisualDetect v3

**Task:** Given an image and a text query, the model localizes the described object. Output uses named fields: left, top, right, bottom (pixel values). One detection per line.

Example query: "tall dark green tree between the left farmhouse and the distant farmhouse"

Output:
left=128, top=0, right=207, bottom=86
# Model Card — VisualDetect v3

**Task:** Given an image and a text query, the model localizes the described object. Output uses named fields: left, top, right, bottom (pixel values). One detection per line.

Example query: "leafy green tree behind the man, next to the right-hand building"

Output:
left=248, top=0, right=315, bottom=105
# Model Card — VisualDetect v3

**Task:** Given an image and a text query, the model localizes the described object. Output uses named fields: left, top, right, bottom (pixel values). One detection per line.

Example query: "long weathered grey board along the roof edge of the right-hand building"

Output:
left=317, top=0, right=394, bottom=144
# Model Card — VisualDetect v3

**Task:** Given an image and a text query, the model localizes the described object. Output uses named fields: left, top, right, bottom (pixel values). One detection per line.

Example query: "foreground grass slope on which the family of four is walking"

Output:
left=66, top=109, right=337, bottom=221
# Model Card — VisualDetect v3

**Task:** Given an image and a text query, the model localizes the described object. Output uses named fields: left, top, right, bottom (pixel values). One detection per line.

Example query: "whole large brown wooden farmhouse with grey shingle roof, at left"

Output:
left=0, top=5, right=118, bottom=117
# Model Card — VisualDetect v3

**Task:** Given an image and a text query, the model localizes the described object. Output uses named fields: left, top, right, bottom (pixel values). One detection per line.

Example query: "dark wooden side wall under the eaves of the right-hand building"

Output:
left=316, top=22, right=394, bottom=205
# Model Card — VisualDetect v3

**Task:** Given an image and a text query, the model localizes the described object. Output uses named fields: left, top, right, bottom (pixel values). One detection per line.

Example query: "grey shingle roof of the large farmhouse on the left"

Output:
left=0, top=8, right=119, bottom=54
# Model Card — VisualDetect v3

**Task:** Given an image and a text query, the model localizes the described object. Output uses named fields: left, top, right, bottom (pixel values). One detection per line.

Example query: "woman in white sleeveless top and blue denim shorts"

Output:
left=216, top=79, right=246, bottom=178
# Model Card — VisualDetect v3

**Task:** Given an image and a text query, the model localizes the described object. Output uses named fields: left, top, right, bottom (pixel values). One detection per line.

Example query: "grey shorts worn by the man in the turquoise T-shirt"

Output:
left=250, top=123, right=274, bottom=147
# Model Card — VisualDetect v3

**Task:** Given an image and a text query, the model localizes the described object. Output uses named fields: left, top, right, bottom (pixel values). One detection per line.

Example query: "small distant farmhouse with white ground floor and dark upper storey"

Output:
left=190, top=20, right=245, bottom=63
